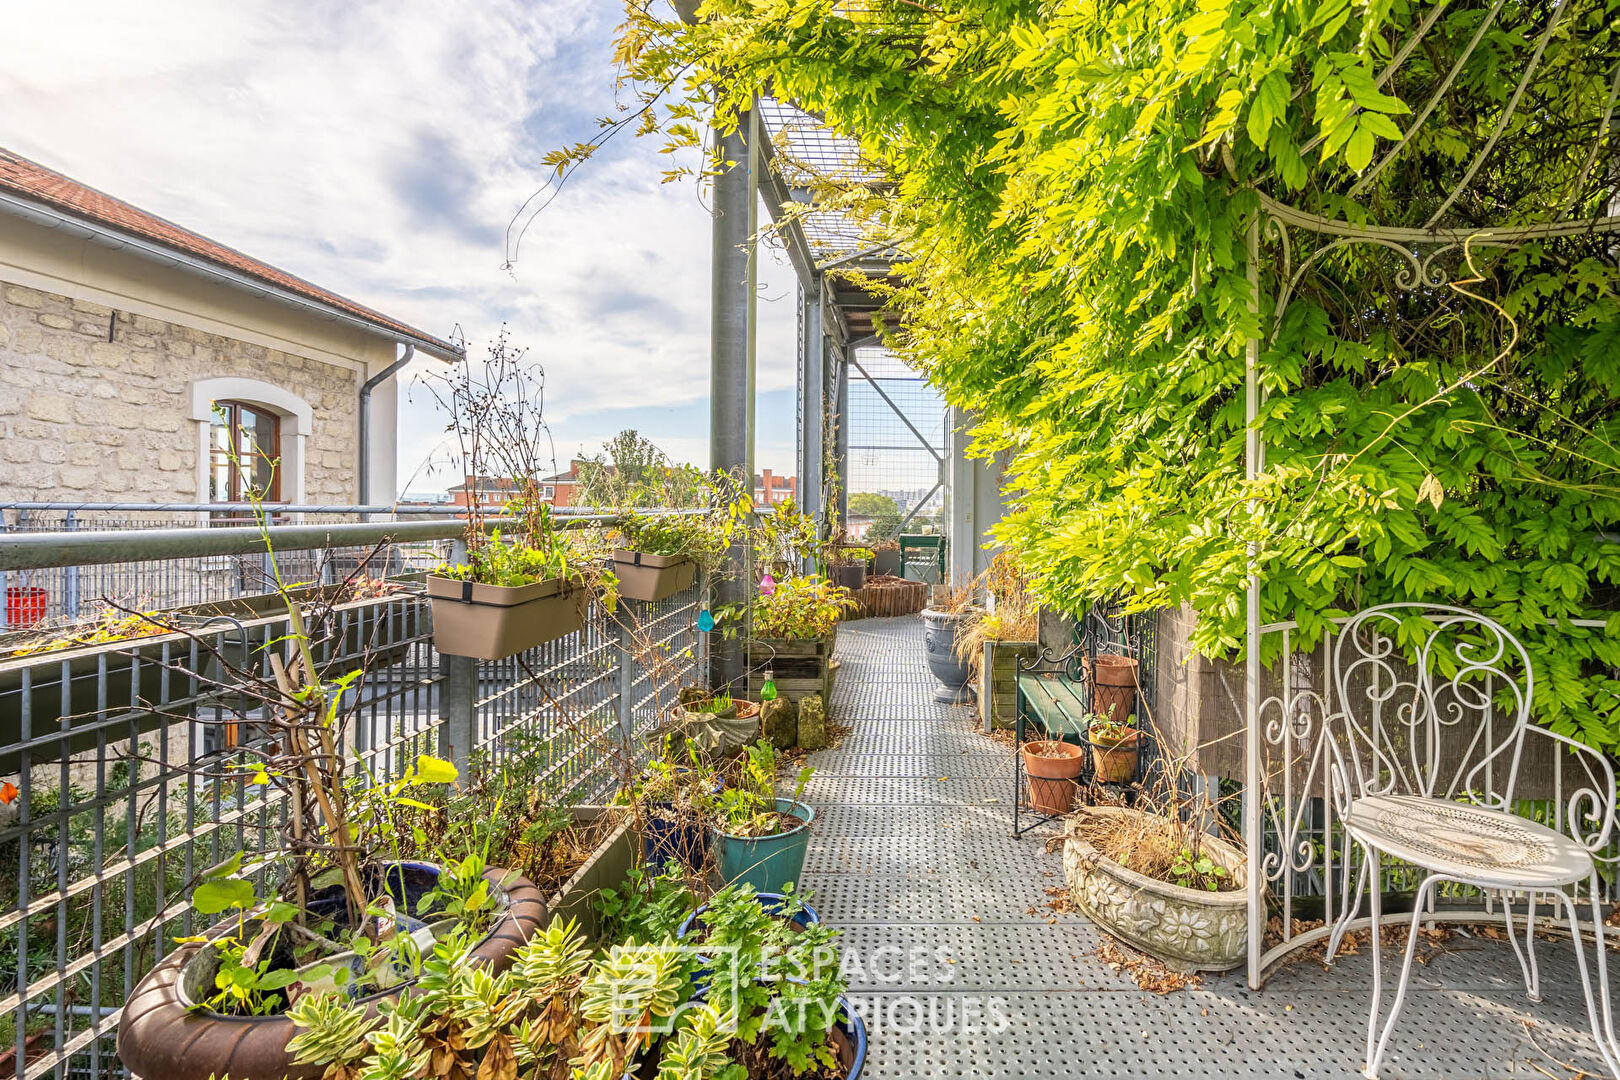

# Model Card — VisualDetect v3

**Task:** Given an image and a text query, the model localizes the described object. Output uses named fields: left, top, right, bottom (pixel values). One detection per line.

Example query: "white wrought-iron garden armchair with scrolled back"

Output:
left=1327, top=604, right=1620, bottom=1077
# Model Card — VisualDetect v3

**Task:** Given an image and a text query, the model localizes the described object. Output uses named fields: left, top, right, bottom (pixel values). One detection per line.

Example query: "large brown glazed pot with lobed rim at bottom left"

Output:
left=118, top=866, right=546, bottom=1080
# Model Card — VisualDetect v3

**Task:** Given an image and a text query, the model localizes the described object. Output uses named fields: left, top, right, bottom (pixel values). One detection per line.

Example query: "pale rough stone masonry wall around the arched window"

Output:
left=0, top=285, right=360, bottom=502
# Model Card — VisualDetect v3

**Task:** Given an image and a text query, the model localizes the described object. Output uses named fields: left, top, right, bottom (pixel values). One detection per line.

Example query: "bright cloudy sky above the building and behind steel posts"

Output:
left=0, top=0, right=795, bottom=492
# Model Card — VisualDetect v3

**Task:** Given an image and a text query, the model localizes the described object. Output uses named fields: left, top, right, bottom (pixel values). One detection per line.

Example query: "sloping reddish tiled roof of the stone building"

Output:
left=0, top=147, right=463, bottom=356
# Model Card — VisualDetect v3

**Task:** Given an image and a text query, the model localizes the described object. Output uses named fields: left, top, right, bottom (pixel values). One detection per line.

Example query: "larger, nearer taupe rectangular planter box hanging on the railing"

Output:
left=428, top=575, right=588, bottom=661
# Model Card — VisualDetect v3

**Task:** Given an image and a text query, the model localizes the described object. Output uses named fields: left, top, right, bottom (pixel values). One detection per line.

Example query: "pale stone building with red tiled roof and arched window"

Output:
left=0, top=149, right=462, bottom=514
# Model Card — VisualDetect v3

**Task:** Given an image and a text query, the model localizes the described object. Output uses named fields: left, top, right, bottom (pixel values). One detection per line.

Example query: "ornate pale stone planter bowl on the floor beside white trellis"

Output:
left=1063, top=806, right=1249, bottom=972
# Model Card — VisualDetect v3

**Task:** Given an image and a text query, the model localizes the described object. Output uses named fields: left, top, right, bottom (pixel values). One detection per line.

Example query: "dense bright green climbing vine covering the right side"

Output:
left=602, top=0, right=1620, bottom=750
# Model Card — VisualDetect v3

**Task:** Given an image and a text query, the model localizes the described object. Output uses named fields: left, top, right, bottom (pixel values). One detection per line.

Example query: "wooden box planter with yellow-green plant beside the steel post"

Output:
left=748, top=575, right=855, bottom=701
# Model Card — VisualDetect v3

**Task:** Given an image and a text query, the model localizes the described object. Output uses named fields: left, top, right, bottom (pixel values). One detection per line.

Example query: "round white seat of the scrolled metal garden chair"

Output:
left=1345, top=795, right=1592, bottom=889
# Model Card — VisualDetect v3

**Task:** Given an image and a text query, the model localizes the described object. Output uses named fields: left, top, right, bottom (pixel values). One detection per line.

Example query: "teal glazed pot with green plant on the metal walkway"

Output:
left=711, top=740, right=815, bottom=892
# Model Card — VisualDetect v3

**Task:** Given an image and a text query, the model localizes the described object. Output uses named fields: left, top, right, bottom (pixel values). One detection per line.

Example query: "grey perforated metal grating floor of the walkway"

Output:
left=804, top=617, right=1602, bottom=1080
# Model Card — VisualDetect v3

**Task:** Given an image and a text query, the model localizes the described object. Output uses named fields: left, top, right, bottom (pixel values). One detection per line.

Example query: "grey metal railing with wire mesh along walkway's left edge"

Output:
left=0, top=518, right=706, bottom=1080
